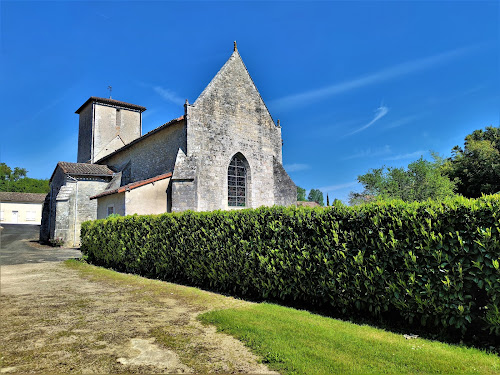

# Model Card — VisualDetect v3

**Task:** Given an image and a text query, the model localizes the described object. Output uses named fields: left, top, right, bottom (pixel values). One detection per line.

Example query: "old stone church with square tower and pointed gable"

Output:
left=40, top=44, right=297, bottom=246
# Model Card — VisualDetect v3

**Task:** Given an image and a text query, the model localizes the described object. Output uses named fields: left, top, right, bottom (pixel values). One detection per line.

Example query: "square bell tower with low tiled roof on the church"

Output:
left=75, top=96, right=146, bottom=164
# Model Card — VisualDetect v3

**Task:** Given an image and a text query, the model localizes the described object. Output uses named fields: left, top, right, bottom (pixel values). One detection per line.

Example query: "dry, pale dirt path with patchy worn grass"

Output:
left=0, top=263, right=276, bottom=373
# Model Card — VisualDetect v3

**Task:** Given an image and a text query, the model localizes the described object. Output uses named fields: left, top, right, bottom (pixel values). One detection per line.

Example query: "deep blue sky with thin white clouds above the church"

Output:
left=0, top=1, right=500, bottom=201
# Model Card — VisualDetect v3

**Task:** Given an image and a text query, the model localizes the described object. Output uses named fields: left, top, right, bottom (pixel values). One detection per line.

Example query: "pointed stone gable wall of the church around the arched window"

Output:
left=183, top=51, right=296, bottom=211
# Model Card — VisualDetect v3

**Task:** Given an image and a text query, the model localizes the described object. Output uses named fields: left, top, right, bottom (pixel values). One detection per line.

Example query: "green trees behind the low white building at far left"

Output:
left=0, top=163, right=50, bottom=193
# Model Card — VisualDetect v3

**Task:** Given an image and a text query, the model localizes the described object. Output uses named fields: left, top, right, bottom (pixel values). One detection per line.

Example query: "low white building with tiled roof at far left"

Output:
left=0, top=192, right=46, bottom=225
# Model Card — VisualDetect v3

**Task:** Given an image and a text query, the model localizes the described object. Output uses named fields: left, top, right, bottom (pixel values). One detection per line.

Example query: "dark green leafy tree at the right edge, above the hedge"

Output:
left=446, top=126, right=500, bottom=198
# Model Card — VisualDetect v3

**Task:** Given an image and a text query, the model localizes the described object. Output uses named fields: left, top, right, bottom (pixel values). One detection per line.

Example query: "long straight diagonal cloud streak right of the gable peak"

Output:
left=270, top=45, right=479, bottom=109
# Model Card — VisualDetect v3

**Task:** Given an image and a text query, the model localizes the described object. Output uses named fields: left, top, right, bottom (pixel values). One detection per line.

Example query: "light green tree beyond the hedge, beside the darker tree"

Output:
left=349, top=154, right=456, bottom=204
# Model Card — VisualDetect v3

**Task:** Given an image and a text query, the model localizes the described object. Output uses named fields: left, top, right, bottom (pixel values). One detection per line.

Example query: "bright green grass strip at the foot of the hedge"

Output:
left=199, top=303, right=500, bottom=374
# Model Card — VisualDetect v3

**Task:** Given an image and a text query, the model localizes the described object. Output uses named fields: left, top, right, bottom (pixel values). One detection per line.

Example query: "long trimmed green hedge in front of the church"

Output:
left=81, top=196, right=500, bottom=336
